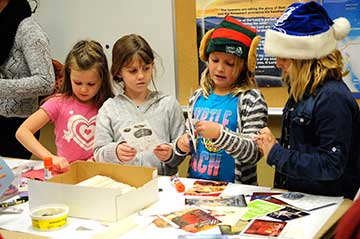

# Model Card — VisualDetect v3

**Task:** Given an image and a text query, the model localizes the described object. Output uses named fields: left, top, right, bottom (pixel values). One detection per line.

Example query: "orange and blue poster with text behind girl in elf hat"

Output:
left=196, top=0, right=293, bottom=86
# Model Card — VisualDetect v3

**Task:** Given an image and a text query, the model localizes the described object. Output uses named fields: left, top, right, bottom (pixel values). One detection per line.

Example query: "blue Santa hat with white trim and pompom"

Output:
left=264, top=2, right=350, bottom=59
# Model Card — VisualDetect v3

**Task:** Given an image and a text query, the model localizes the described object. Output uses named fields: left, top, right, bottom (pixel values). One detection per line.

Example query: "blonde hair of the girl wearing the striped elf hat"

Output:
left=200, top=57, right=256, bottom=97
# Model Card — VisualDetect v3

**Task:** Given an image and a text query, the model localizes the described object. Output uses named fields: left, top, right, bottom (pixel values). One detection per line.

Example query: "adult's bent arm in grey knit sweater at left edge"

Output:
left=0, top=17, right=55, bottom=99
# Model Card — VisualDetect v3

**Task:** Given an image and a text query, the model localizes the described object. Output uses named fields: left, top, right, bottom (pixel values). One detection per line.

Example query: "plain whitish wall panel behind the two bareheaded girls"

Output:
left=34, top=0, right=177, bottom=96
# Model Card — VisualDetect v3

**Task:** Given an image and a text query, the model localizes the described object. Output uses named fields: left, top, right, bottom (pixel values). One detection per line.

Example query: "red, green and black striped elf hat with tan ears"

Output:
left=199, top=16, right=260, bottom=72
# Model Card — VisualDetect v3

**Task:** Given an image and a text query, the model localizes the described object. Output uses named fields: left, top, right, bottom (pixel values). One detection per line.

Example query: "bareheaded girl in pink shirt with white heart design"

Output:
left=16, top=40, right=113, bottom=172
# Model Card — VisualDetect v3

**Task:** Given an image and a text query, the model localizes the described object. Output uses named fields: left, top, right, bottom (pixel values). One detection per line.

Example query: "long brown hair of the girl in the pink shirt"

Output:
left=59, top=40, right=114, bottom=107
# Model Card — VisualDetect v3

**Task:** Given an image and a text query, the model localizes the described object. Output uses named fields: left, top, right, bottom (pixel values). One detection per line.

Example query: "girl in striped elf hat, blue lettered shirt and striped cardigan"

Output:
left=177, top=16, right=267, bottom=185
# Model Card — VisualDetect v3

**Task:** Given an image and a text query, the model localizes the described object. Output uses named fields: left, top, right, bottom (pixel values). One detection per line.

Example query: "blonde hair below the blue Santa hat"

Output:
left=287, top=50, right=348, bottom=102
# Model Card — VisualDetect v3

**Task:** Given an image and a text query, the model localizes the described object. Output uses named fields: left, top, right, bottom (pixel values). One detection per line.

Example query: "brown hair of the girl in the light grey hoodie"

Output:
left=110, top=34, right=156, bottom=89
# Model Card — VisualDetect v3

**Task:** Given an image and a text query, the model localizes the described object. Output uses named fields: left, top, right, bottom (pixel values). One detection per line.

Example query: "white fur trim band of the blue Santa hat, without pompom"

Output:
left=264, top=28, right=337, bottom=59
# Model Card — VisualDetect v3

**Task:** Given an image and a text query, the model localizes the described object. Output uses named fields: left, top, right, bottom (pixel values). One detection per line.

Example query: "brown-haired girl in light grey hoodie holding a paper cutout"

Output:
left=94, top=34, right=185, bottom=175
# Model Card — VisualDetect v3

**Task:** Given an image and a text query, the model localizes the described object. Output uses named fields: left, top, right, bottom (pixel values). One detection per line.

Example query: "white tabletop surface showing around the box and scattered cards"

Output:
left=0, top=162, right=352, bottom=239
